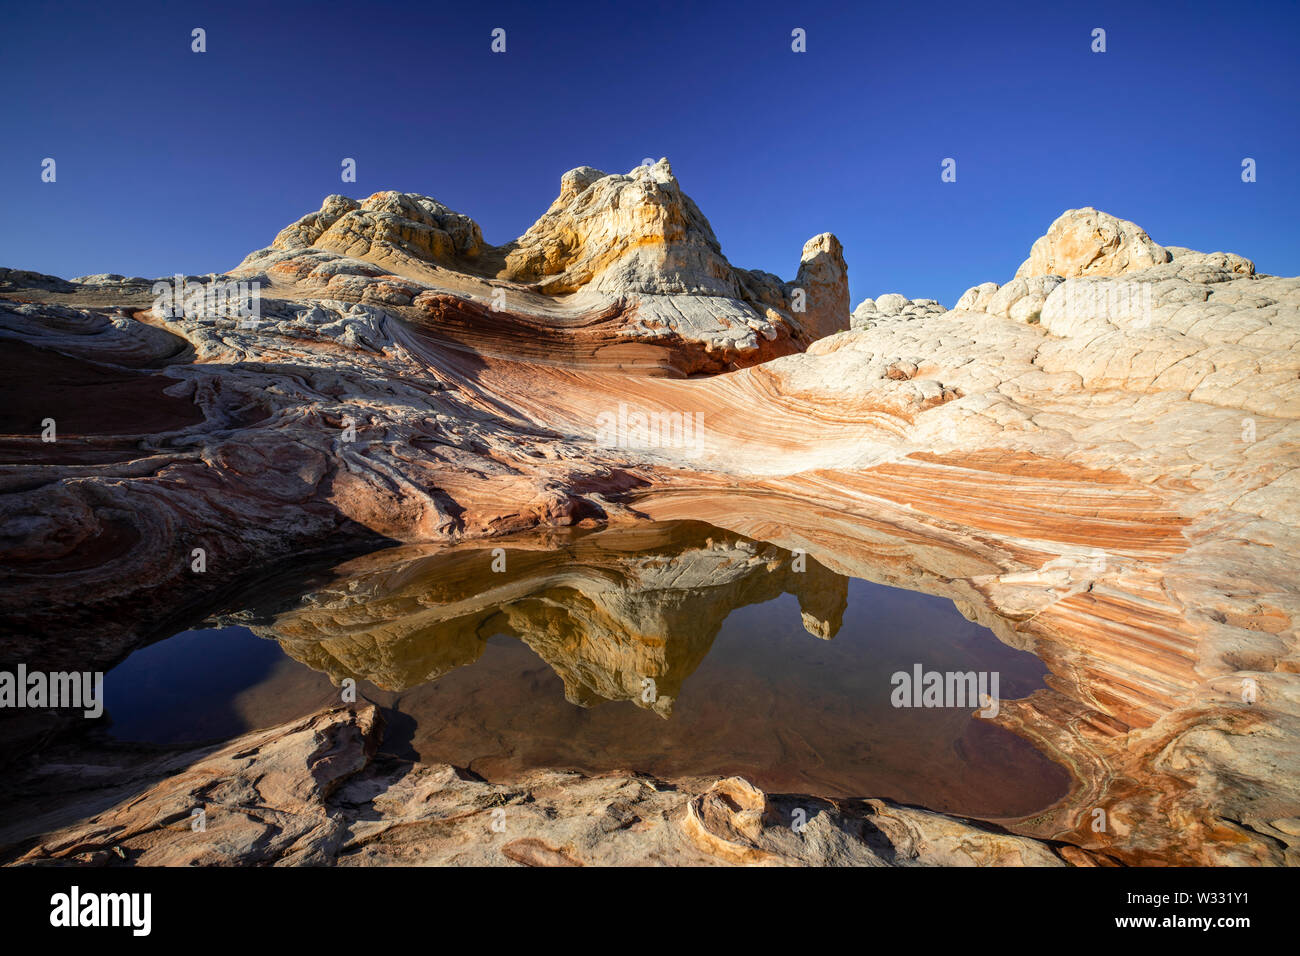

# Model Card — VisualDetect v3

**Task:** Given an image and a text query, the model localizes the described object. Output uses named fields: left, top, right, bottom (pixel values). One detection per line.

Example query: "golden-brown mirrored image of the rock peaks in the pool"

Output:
left=235, top=522, right=848, bottom=715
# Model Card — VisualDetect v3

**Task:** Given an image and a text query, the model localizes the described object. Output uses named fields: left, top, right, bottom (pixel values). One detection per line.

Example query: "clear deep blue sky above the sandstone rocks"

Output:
left=0, top=1, right=1300, bottom=306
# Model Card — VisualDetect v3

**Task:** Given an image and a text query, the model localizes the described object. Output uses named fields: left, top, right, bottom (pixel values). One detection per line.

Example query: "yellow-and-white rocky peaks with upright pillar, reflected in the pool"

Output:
left=235, top=160, right=849, bottom=375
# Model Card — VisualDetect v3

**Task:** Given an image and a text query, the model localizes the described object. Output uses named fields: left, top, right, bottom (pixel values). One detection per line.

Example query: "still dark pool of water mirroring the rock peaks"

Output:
left=105, top=523, right=1069, bottom=817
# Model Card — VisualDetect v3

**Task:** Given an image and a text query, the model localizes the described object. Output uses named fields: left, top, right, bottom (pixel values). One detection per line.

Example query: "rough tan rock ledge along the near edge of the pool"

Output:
left=0, top=706, right=1071, bottom=866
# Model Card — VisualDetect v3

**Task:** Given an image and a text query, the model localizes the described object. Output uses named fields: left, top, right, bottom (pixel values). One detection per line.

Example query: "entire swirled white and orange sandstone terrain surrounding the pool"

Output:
left=0, top=161, right=1300, bottom=864
